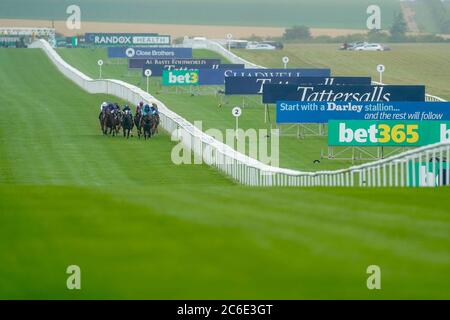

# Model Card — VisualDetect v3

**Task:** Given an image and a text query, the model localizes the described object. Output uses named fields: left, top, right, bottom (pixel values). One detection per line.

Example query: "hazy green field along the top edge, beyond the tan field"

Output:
left=0, top=0, right=400, bottom=29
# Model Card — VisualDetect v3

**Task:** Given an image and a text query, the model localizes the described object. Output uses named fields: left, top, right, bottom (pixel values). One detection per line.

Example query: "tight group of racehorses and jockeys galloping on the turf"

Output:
left=98, top=102, right=160, bottom=140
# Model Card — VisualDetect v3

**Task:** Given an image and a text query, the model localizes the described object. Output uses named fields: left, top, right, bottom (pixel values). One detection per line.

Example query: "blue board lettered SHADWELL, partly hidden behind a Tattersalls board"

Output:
left=200, top=68, right=331, bottom=85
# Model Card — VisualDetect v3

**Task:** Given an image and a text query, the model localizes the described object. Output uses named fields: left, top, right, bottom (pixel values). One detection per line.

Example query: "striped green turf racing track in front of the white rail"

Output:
left=0, top=49, right=450, bottom=299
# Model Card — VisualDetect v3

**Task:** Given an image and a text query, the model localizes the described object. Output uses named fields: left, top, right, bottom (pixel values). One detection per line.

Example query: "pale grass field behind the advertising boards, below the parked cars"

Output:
left=235, top=44, right=450, bottom=100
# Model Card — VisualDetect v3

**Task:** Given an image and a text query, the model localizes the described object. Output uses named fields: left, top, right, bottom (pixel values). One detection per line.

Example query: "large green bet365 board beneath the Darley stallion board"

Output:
left=328, top=120, right=450, bottom=147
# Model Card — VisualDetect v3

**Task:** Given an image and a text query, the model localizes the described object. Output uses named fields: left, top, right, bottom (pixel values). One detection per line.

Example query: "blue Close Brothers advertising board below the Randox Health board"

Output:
left=108, top=47, right=192, bottom=59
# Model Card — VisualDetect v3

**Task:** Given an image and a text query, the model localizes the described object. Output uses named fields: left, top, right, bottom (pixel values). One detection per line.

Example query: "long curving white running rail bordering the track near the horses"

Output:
left=31, top=40, right=450, bottom=187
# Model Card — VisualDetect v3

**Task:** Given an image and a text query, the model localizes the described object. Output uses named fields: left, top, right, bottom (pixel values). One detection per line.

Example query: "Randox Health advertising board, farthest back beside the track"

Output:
left=84, top=33, right=170, bottom=46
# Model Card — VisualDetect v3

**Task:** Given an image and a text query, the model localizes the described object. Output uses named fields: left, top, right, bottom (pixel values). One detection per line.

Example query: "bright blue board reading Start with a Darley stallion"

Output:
left=276, top=101, right=450, bottom=124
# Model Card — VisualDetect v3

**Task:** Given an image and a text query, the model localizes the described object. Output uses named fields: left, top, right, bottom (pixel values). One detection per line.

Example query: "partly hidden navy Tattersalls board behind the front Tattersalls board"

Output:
left=225, top=77, right=372, bottom=95
